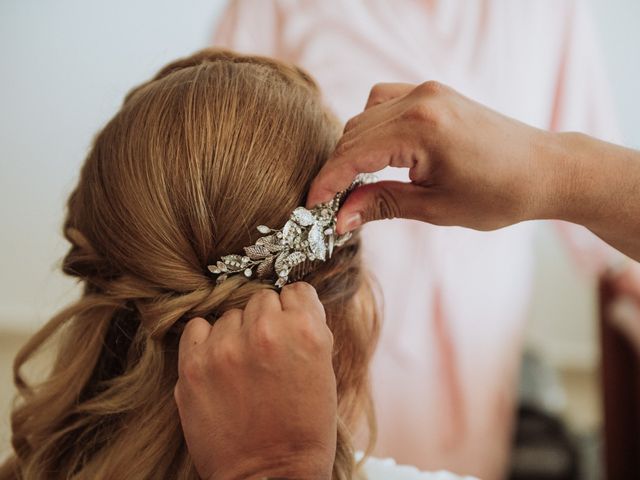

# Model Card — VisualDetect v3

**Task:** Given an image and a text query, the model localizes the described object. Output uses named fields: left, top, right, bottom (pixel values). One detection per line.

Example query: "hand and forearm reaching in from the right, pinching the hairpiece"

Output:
left=307, top=82, right=640, bottom=260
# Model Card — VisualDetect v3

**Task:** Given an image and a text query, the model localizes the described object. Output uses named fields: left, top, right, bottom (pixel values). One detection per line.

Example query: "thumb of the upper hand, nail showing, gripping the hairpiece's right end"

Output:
left=336, top=181, right=428, bottom=235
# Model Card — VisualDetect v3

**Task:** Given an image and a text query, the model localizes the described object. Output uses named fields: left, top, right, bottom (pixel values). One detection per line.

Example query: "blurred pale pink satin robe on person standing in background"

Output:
left=213, top=0, right=617, bottom=480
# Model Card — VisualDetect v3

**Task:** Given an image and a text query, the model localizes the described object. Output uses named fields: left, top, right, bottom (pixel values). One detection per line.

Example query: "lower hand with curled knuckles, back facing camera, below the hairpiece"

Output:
left=175, top=282, right=337, bottom=480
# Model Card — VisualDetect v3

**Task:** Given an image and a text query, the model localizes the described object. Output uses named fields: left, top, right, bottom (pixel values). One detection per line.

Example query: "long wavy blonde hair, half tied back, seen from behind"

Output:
left=0, top=49, right=378, bottom=480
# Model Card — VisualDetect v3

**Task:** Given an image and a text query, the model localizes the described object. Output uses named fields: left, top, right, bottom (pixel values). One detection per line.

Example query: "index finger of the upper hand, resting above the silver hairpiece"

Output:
left=307, top=120, right=413, bottom=208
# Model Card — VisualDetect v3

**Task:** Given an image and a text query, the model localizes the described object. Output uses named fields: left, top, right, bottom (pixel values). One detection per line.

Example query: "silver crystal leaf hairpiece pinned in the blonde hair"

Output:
left=208, top=174, right=376, bottom=288
